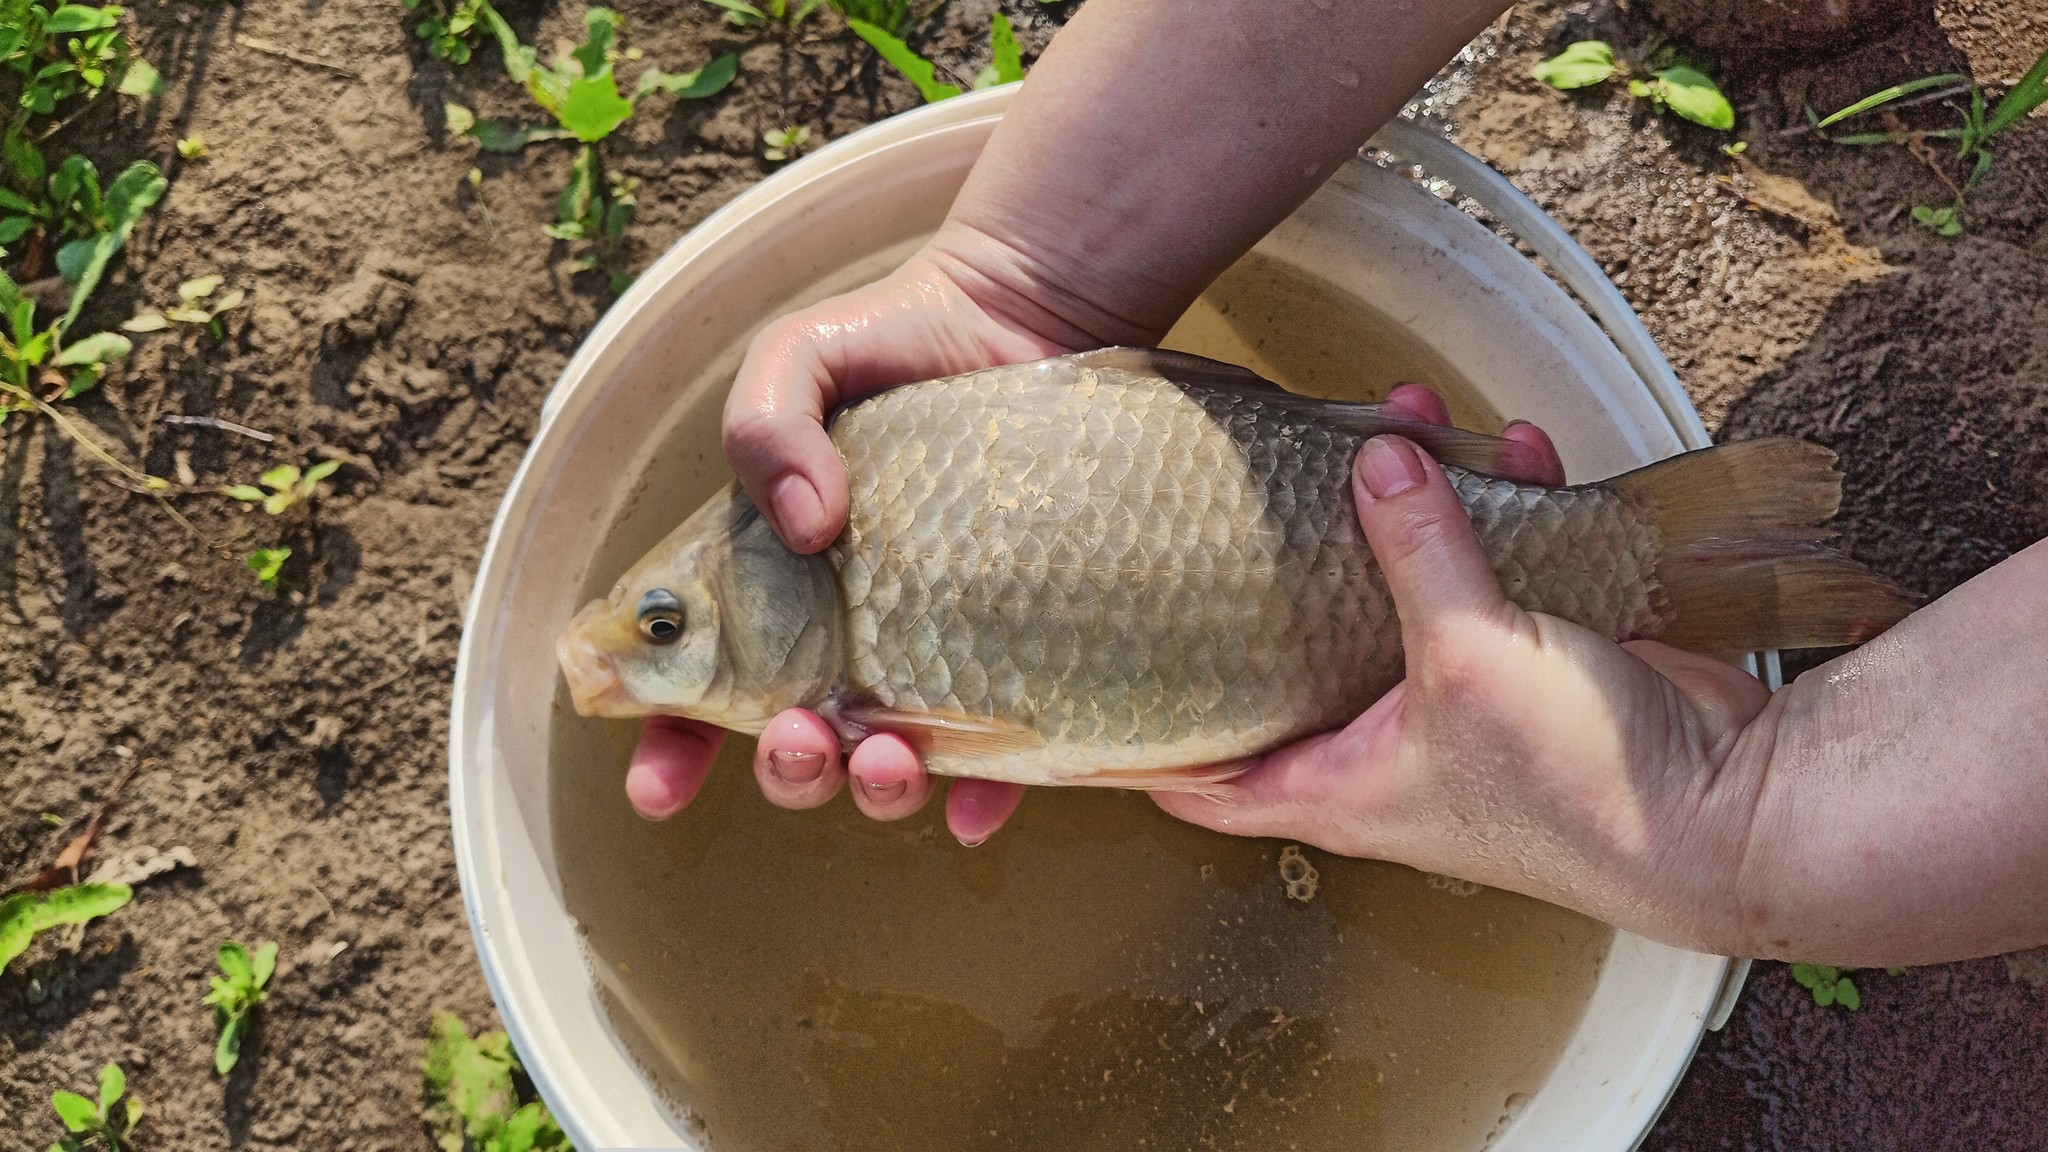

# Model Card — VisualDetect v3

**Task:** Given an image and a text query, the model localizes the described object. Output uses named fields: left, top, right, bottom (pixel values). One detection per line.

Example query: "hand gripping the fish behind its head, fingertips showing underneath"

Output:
left=627, top=225, right=1122, bottom=842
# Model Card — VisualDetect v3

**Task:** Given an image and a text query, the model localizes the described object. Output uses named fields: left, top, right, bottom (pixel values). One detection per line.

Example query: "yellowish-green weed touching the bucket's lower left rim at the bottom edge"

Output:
left=420, top=1013, right=573, bottom=1152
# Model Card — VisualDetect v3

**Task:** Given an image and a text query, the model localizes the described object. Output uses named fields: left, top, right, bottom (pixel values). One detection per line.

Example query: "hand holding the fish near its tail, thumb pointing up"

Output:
left=1155, top=426, right=1769, bottom=947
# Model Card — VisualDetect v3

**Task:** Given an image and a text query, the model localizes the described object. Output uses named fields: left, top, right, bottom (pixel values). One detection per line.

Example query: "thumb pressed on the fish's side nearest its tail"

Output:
left=1352, top=437, right=1507, bottom=660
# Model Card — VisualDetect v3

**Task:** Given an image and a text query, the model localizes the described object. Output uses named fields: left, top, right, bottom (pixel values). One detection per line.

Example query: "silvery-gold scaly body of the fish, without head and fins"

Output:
left=829, top=354, right=1655, bottom=779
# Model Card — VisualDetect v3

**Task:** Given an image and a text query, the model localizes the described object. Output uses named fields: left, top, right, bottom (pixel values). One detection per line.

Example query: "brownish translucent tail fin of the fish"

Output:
left=1604, top=437, right=1913, bottom=652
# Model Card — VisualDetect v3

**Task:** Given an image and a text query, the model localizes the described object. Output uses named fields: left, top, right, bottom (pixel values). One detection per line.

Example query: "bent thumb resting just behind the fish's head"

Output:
left=723, top=318, right=846, bottom=553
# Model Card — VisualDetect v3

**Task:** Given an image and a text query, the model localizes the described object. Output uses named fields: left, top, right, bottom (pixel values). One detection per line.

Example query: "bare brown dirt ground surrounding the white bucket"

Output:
left=0, top=0, right=2048, bottom=1152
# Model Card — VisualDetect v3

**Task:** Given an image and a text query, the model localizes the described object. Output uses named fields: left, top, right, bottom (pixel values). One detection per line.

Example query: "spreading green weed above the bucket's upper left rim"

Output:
left=446, top=0, right=739, bottom=280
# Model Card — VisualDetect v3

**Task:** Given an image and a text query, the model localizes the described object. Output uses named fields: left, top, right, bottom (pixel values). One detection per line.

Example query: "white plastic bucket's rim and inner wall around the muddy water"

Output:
left=451, top=88, right=1745, bottom=1152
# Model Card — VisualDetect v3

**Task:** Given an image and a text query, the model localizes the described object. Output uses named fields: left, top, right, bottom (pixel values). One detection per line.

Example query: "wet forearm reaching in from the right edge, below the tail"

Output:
left=1731, top=541, right=2048, bottom=965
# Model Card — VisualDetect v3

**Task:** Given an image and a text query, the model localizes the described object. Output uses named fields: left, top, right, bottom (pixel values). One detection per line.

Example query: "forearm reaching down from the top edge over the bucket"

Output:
left=938, top=0, right=1507, bottom=346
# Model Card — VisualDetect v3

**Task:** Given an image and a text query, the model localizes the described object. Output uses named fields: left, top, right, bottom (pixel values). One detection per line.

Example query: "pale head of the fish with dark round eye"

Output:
left=555, top=486, right=844, bottom=732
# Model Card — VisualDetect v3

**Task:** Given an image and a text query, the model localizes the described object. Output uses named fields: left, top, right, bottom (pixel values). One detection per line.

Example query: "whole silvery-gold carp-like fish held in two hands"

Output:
left=557, top=348, right=1911, bottom=789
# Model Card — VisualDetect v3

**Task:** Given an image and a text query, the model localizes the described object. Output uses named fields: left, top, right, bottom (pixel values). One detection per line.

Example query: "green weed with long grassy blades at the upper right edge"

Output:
left=1806, top=41, right=2048, bottom=236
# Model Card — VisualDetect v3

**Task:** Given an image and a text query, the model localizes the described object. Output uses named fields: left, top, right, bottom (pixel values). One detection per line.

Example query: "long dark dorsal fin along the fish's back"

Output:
left=1071, top=348, right=1546, bottom=478
